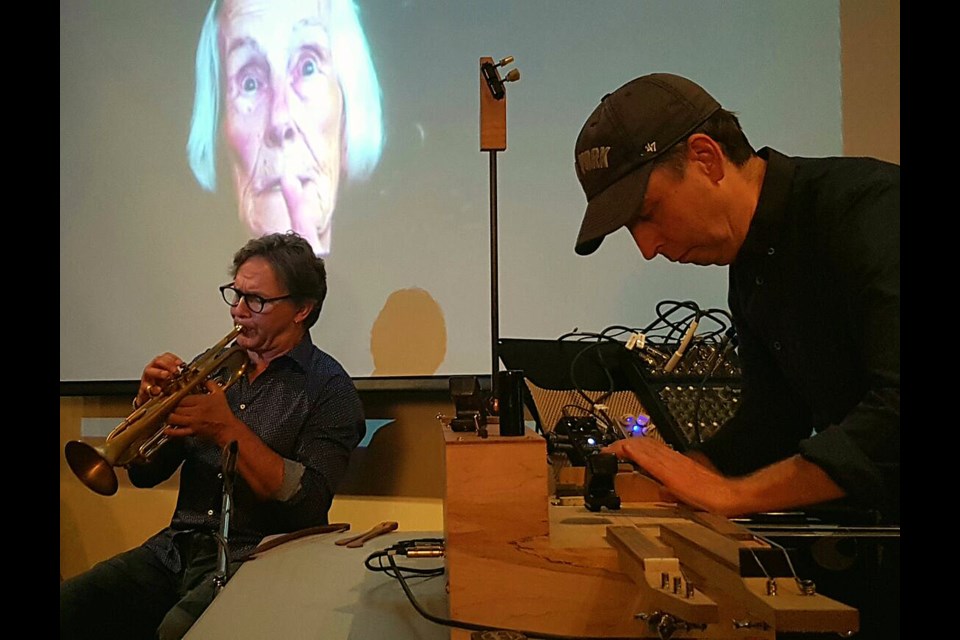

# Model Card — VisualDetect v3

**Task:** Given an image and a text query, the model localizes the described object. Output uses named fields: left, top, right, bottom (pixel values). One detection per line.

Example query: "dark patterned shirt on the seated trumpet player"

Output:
left=129, top=332, right=366, bottom=571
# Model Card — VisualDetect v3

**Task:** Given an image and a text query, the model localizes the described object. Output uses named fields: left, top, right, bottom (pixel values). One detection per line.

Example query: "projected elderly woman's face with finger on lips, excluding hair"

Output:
left=220, top=0, right=343, bottom=255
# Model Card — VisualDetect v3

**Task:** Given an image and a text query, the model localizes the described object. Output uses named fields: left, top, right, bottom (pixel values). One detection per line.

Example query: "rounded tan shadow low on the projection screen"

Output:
left=370, top=288, right=447, bottom=376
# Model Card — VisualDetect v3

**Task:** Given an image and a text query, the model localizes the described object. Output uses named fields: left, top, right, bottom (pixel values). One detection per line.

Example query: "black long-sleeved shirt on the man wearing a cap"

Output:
left=701, top=149, right=900, bottom=521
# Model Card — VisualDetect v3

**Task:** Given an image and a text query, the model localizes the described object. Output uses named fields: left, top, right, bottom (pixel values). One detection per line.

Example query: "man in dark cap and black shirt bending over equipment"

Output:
left=574, top=73, right=900, bottom=522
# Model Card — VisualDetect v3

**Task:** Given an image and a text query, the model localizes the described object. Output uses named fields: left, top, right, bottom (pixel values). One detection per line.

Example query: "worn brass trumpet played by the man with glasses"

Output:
left=64, top=325, right=250, bottom=496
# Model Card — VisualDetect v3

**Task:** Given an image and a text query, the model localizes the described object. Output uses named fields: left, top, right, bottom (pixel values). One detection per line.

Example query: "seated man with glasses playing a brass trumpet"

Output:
left=60, top=233, right=365, bottom=639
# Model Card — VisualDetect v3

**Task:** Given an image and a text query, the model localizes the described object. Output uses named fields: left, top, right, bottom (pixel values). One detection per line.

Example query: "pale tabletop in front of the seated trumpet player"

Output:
left=186, top=531, right=450, bottom=640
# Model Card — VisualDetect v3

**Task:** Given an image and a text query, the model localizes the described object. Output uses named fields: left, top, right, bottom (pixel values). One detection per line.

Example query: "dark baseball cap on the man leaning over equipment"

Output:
left=573, top=73, right=720, bottom=256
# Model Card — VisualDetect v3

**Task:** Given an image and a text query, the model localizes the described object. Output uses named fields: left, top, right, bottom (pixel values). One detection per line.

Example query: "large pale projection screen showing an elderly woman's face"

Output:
left=60, top=0, right=842, bottom=382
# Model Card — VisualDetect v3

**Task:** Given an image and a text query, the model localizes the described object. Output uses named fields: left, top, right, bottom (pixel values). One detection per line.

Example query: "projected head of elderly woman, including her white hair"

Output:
left=187, top=0, right=383, bottom=255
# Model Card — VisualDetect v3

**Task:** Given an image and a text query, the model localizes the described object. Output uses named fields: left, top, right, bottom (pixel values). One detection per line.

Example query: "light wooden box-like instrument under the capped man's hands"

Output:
left=443, top=423, right=859, bottom=640
